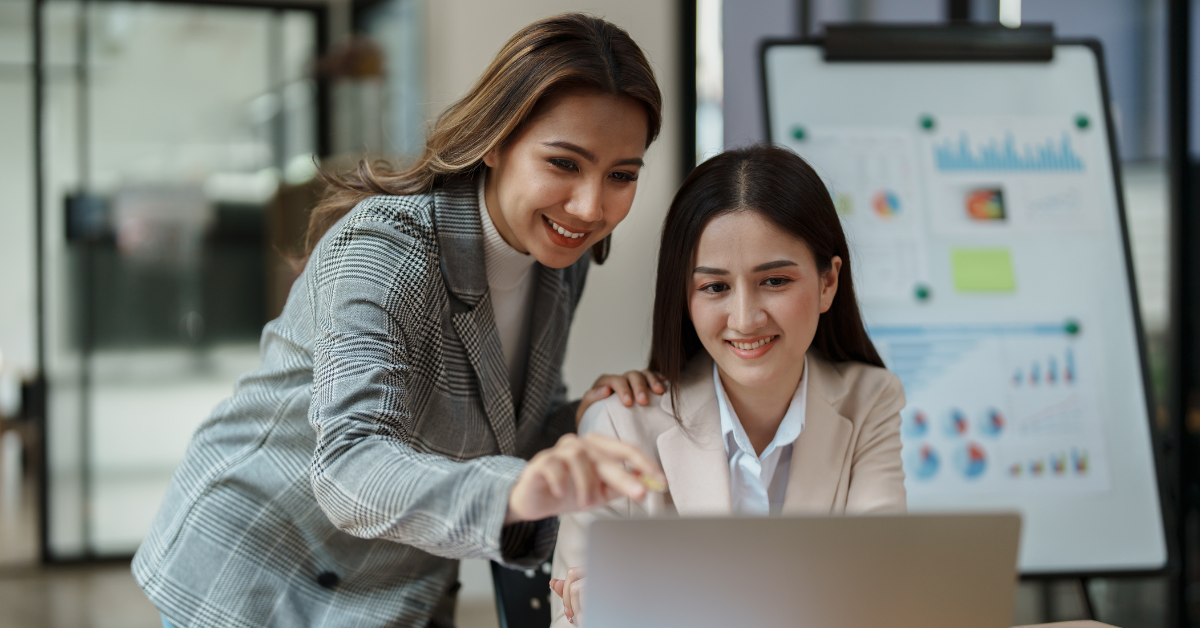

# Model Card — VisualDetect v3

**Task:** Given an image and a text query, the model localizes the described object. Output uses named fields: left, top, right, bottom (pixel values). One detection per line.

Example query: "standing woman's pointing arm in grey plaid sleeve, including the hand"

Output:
left=306, top=208, right=664, bottom=567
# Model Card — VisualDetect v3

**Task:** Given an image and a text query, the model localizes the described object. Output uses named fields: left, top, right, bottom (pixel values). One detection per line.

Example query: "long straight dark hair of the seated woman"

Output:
left=650, top=145, right=883, bottom=418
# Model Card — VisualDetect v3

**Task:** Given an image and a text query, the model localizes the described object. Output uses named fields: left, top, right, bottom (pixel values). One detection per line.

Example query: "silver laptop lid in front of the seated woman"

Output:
left=583, top=514, right=1021, bottom=628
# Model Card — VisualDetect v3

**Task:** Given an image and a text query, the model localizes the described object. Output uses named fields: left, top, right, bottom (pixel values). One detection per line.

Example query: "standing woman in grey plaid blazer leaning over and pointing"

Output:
left=133, top=14, right=665, bottom=628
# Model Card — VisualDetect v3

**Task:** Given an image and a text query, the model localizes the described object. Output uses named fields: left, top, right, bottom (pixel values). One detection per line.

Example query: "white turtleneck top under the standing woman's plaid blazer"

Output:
left=478, top=175, right=538, bottom=398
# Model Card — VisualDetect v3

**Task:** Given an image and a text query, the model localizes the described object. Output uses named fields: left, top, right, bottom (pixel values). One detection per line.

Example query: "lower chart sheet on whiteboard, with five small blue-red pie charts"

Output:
left=871, top=322, right=1109, bottom=496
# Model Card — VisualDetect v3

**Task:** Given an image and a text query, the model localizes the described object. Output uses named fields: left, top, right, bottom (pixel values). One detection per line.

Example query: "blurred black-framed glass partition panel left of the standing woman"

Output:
left=43, top=0, right=318, bottom=558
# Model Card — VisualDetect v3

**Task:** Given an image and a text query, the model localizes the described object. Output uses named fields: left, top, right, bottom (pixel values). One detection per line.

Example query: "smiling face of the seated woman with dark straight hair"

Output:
left=688, top=210, right=841, bottom=391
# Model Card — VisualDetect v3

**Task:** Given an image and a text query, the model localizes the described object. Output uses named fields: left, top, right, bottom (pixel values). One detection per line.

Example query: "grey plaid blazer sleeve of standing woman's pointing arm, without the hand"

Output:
left=308, top=207, right=542, bottom=566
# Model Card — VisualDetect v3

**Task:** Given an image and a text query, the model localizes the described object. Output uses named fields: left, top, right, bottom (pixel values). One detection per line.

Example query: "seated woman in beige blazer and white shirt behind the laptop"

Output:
left=551, top=146, right=905, bottom=626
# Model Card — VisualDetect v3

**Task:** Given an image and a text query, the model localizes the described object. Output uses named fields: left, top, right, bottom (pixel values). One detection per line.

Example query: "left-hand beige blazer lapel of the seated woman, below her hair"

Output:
left=658, top=353, right=733, bottom=515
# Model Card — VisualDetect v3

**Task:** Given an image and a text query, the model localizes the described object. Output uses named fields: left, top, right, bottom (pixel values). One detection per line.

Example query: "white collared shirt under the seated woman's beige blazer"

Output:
left=713, top=357, right=809, bottom=515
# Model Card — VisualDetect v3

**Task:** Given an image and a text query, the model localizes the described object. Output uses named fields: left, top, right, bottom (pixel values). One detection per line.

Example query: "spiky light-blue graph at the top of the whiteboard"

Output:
left=934, top=131, right=1084, bottom=172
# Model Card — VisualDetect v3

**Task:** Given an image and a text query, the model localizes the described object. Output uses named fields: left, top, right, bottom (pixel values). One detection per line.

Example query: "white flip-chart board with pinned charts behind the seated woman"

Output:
left=763, top=43, right=1166, bottom=575
